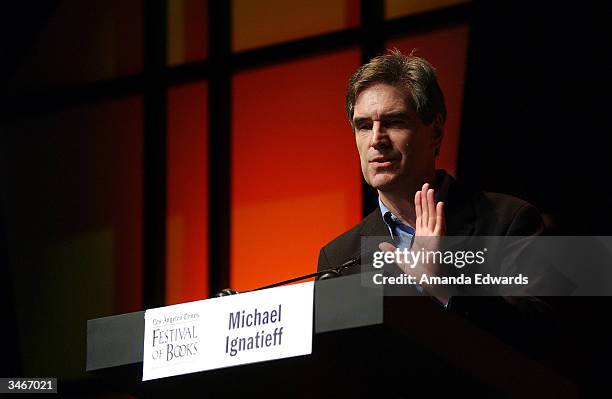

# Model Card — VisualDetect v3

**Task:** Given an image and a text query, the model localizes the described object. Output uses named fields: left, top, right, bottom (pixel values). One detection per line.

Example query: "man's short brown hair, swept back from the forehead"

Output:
left=346, top=49, right=446, bottom=130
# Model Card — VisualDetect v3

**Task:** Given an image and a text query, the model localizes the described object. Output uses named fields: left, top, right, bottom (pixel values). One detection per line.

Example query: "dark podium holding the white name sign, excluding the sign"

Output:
left=86, top=274, right=578, bottom=398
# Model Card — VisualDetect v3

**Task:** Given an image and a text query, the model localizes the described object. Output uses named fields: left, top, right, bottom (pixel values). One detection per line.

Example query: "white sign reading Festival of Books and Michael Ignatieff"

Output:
left=142, top=282, right=314, bottom=381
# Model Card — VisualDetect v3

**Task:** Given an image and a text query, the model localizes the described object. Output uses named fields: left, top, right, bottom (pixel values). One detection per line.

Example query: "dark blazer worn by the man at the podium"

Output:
left=318, top=171, right=550, bottom=353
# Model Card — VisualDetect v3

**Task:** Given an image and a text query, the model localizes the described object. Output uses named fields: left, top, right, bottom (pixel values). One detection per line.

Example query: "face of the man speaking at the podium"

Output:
left=353, top=83, right=441, bottom=191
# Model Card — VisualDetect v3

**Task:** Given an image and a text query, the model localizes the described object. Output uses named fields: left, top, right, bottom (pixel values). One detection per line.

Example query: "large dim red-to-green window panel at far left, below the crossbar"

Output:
left=0, top=97, right=143, bottom=376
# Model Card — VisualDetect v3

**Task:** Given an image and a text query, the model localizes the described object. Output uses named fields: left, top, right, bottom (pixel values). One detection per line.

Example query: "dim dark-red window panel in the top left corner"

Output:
left=12, top=0, right=143, bottom=91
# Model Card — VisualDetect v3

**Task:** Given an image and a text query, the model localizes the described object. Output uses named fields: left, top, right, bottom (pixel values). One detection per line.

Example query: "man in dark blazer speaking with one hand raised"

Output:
left=318, top=50, right=543, bottom=322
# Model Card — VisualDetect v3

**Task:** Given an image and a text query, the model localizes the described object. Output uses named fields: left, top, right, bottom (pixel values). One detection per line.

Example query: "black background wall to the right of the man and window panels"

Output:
left=459, top=2, right=611, bottom=235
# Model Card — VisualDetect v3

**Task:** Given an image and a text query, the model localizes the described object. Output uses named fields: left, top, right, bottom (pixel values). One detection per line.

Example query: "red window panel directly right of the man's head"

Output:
left=386, top=25, right=469, bottom=175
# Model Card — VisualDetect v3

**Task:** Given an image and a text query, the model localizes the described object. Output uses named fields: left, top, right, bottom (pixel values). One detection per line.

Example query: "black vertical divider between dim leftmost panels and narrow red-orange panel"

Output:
left=142, top=0, right=167, bottom=309
